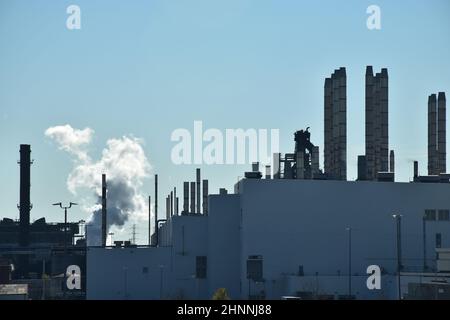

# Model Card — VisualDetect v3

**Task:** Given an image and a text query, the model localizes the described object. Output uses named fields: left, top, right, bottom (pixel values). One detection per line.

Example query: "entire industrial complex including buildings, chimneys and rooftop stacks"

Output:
left=0, top=66, right=450, bottom=300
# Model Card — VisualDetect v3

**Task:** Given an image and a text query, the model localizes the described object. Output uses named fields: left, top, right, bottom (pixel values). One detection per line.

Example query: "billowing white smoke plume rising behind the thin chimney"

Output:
left=45, top=125, right=151, bottom=242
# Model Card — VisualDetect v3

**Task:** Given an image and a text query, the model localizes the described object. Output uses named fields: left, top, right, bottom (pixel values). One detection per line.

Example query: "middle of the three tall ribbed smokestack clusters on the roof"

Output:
left=365, top=66, right=389, bottom=180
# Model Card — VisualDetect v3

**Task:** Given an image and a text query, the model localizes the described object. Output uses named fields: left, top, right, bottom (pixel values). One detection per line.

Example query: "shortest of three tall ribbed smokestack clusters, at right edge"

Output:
left=428, top=92, right=447, bottom=175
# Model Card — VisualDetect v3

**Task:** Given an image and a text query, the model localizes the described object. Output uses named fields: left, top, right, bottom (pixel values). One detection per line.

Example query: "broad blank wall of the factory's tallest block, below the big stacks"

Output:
left=237, top=180, right=450, bottom=299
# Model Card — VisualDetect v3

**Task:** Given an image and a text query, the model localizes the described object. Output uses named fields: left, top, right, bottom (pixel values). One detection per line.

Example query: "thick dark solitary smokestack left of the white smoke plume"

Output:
left=19, top=144, right=32, bottom=248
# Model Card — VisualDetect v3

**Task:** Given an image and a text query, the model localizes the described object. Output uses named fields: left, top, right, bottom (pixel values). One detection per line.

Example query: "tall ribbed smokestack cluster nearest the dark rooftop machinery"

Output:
left=324, top=68, right=347, bottom=180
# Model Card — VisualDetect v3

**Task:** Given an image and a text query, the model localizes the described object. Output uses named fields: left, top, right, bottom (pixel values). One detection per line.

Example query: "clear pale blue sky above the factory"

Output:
left=0, top=0, right=450, bottom=241
